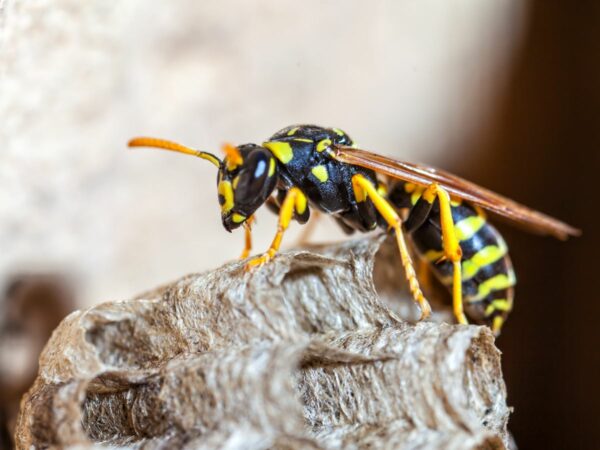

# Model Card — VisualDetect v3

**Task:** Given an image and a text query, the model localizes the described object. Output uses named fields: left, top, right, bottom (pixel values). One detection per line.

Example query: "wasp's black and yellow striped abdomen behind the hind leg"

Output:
left=412, top=203, right=516, bottom=330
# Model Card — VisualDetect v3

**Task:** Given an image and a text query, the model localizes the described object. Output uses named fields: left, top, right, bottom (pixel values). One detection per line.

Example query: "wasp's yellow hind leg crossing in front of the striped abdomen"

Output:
left=423, top=183, right=469, bottom=324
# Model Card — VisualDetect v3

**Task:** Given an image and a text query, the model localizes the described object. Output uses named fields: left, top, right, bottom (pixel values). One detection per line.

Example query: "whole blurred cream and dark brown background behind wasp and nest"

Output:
left=0, top=0, right=600, bottom=448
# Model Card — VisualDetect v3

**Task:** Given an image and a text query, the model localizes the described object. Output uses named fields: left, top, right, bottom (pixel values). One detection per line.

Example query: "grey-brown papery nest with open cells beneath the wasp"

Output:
left=16, top=237, right=510, bottom=449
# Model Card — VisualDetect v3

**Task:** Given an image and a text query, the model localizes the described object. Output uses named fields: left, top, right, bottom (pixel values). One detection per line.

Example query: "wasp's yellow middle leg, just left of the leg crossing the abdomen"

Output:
left=352, top=174, right=431, bottom=320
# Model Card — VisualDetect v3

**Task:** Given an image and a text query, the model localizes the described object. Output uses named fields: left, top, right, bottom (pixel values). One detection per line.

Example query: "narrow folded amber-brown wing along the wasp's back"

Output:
left=332, top=146, right=581, bottom=240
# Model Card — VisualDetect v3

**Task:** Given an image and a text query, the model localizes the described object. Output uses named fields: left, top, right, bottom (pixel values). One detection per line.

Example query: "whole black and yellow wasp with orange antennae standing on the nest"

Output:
left=129, top=125, right=580, bottom=334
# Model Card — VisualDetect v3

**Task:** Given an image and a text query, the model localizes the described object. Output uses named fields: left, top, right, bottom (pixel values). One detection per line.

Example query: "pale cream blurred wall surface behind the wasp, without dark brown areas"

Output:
left=0, top=0, right=526, bottom=306
